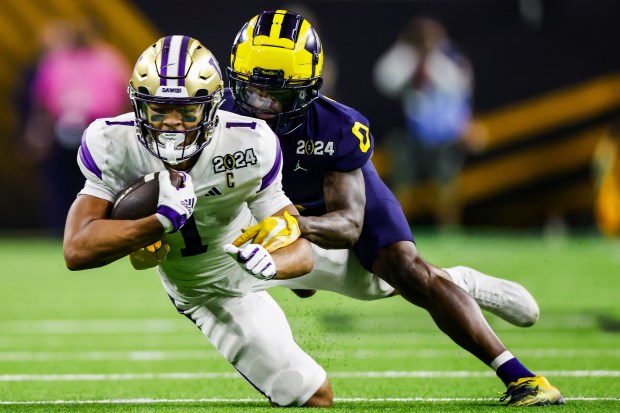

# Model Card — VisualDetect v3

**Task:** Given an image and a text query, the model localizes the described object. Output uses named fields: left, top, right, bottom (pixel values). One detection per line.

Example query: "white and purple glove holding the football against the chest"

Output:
left=157, top=170, right=196, bottom=234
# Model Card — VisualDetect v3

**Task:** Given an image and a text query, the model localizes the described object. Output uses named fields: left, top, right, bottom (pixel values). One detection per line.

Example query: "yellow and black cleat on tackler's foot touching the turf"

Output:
left=499, top=376, right=565, bottom=406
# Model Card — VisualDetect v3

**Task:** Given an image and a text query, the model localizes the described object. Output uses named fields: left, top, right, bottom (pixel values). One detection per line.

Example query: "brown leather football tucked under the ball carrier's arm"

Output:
left=110, top=171, right=183, bottom=220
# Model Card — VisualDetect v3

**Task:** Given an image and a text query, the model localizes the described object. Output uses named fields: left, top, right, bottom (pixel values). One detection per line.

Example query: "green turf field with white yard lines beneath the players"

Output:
left=0, top=233, right=620, bottom=413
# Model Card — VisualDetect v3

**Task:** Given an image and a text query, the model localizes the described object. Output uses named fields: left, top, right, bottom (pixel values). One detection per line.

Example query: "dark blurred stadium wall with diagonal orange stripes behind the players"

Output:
left=0, top=0, right=620, bottom=229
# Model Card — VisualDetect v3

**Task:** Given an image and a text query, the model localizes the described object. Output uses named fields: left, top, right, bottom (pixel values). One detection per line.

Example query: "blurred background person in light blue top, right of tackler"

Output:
left=374, top=17, right=474, bottom=228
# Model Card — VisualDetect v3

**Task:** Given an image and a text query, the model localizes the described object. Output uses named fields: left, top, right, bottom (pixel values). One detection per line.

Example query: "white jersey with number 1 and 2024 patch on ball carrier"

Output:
left=78, top=110, right=290, bottom=301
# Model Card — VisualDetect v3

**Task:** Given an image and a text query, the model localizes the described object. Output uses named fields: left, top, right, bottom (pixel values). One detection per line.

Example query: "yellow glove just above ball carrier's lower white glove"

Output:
left=233, top=211, right=301, bottom=252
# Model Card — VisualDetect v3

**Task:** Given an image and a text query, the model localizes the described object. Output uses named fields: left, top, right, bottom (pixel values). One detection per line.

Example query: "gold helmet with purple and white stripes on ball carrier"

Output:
left=128, top=36, right=223, bottom=165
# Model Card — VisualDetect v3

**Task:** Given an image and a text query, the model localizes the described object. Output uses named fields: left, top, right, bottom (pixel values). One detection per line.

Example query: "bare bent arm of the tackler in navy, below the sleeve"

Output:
left=297, top=169, right=366, bottom=249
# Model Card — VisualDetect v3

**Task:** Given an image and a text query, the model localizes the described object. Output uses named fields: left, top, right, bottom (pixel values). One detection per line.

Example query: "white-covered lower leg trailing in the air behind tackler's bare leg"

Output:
left=447, top=266, right=539, bottom=327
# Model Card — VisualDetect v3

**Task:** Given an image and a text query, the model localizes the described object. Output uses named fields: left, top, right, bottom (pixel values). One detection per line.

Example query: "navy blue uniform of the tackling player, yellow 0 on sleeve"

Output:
left=222, top=90, right=413, bottom=270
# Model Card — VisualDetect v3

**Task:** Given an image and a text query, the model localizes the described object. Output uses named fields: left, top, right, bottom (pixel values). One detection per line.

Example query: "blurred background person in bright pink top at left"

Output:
left=16, top=18, right=131, bottom=234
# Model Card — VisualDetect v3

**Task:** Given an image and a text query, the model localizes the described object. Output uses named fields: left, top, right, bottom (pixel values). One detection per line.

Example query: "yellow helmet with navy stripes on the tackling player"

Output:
left=228, top=10, right=323, bottom=135
